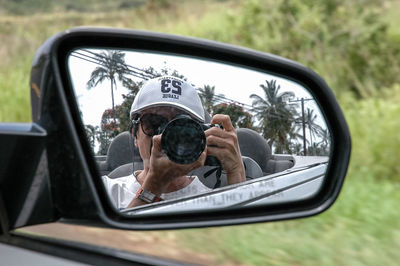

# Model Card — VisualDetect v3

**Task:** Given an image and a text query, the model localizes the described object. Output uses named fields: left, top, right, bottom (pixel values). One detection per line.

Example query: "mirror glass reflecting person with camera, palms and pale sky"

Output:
left=68, top=48, right=331, bottom=215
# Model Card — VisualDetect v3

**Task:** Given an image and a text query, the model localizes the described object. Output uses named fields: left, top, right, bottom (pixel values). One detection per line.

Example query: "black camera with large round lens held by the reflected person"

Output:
left=159, top=115, right=222, bottom=166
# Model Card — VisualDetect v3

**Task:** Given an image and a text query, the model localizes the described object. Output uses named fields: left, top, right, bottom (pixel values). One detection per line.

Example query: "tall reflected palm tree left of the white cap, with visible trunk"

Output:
left=86, top=50, right=133, bottom=124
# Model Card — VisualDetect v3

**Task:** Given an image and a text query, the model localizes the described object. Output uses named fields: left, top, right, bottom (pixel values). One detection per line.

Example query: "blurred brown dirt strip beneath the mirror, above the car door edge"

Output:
left=19, top=223, right=219, bottom=265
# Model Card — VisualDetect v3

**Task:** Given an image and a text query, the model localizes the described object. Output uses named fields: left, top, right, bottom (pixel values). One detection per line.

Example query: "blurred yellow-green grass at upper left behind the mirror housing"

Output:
left=0, top=1, right=236, bottom=122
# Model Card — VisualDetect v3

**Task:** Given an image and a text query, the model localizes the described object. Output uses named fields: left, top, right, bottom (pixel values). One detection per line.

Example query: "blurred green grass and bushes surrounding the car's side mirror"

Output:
left=0, top=0, right=400, bottom=265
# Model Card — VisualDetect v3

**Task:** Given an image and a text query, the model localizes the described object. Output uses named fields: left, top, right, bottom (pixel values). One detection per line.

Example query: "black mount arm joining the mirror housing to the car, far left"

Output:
left=0, top=123, right=54, bottom=231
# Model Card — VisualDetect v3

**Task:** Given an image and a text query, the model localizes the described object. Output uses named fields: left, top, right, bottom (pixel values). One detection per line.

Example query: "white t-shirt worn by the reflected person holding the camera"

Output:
left=102, top=174, right=211, bottom=210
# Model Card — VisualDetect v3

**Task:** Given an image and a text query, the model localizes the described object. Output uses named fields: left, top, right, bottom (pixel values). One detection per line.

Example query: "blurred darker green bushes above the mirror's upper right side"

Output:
left=225, top=0, right=400, bottom=99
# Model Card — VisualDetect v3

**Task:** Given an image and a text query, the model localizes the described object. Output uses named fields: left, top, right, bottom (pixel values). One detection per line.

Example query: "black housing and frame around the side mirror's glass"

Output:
left=0, top=28, right=351, bottom=230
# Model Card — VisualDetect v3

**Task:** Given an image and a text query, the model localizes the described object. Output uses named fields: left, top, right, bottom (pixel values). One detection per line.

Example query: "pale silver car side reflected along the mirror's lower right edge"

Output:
left=124, top=156, right=329, bottom=215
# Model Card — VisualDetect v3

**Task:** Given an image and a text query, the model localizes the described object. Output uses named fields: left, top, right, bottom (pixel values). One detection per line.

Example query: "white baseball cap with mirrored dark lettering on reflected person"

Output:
left=130, top=76, right=204, bottom=122
